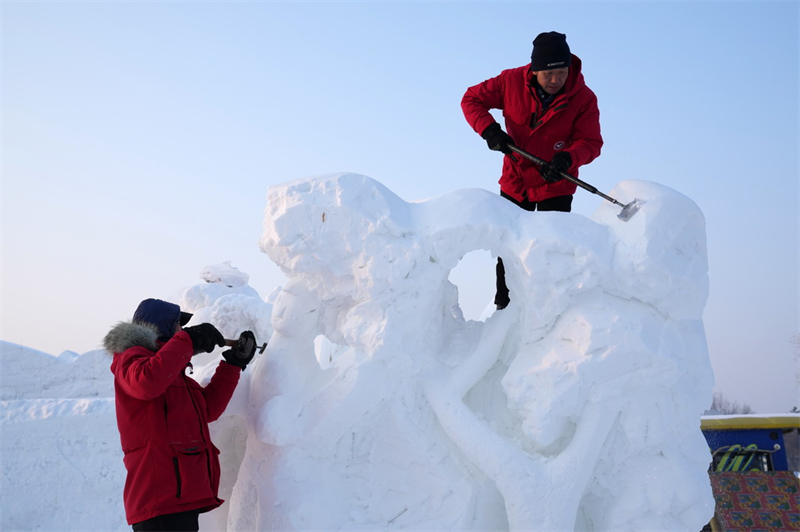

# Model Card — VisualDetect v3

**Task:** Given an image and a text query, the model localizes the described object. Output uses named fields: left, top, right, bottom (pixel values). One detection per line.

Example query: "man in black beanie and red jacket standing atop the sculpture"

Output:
left=461, top=31, right=603, bottom=308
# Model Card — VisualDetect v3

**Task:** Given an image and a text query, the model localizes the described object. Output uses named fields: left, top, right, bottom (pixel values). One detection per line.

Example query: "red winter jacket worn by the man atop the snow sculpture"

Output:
left=461, top=55, right=603, bottom=201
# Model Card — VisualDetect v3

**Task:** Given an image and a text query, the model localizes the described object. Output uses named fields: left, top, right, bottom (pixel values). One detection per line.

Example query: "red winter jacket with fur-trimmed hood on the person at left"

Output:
left=105, top=322, right=241, bottom=525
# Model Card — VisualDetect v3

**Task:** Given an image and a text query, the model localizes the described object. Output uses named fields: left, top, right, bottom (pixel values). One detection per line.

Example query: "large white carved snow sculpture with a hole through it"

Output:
left=223, top=174, right=714, bottom=530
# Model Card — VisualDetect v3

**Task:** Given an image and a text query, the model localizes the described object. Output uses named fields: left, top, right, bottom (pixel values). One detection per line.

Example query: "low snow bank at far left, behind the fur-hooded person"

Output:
left=0, top=342, right=125, bottom=531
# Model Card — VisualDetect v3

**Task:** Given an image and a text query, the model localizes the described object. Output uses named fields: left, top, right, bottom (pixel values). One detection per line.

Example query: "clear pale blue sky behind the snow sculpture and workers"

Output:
left=0, top=1, right=800, bottom=413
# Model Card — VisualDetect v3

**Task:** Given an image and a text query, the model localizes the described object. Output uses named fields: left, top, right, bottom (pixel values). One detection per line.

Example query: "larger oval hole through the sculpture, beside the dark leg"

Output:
left=448, top=249, right=497, bottom=321
